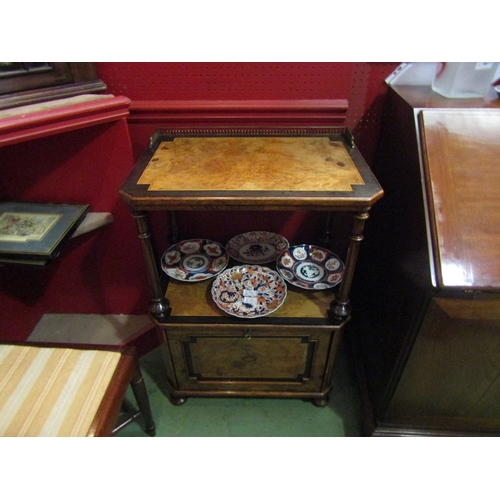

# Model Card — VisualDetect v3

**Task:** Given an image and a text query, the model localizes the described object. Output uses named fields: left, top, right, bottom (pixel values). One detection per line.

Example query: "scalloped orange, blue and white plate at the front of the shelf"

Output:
left=212, top=265, right=286, bottom=318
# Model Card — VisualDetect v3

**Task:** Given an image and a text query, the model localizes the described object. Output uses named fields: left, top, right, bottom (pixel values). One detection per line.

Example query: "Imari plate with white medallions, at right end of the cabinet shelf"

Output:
left=276, top=245, right=344, bottom=290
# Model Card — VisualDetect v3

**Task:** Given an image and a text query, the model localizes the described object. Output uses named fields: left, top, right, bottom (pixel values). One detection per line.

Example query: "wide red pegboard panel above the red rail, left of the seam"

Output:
left=96, top=63, right=352, bottom=100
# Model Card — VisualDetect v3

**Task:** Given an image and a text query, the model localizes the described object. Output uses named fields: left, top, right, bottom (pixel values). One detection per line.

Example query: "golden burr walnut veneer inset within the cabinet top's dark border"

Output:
left=138, top=137, right=364, bottom=191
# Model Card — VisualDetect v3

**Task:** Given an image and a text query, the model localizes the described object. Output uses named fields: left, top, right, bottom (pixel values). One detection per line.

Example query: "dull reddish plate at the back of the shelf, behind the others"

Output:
left=226, top=231, right=290, bottom=264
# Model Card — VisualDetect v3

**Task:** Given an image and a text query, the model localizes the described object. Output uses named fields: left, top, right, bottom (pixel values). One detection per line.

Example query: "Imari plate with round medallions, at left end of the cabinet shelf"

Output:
left=161, top=239, right=229, bottom=281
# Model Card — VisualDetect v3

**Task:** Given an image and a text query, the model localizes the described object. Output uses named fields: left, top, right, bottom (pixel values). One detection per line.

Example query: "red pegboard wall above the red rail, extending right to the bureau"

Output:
left=96, top=62, right=399, bottom=163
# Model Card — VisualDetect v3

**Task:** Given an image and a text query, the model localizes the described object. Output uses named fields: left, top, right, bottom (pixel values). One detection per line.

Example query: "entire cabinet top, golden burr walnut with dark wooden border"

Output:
left=122, top=137, right=382, bottom=206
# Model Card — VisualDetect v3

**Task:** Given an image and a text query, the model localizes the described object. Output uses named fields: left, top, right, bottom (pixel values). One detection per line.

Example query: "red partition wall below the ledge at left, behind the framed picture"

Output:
left=0, top=119, right=148, bottom=340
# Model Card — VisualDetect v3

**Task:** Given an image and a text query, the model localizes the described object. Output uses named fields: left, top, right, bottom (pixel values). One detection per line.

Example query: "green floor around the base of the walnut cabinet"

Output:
left=116, top=340, right=361, bottom=439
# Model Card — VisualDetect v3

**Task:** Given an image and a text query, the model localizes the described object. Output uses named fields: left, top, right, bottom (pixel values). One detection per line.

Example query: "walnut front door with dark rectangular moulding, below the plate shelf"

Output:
left=167, top=328, right=332, bottom=391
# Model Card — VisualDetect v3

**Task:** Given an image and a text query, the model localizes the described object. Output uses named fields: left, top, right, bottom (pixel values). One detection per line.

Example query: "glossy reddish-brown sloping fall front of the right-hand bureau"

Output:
left=419, top=109, right=500, bottom=288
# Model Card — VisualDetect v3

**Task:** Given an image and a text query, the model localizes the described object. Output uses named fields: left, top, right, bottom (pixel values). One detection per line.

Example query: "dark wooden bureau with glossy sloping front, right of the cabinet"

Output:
left=351, top=87, right=500, bottom=435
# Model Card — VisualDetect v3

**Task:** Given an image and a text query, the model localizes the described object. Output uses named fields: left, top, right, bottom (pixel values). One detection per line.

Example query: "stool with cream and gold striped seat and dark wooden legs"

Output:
left=0, top=343, right=155, bottom=436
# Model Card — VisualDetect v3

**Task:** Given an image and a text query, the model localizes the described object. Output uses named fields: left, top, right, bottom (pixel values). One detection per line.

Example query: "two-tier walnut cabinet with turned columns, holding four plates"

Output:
left=120, top=129, right=383, bottom=406
